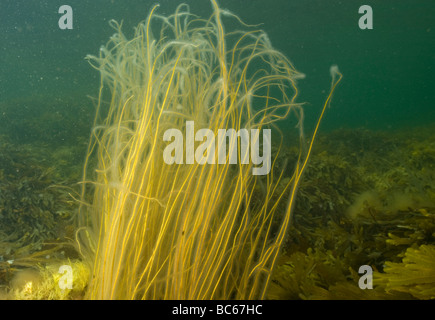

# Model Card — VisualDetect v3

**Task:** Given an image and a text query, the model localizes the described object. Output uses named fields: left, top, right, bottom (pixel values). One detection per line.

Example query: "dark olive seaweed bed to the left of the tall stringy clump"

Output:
left=0, top=99, right=88, bottom=299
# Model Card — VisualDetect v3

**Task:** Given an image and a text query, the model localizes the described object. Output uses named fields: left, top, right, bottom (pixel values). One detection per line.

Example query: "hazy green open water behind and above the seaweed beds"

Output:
left=0, top=0, right=435, bottom=129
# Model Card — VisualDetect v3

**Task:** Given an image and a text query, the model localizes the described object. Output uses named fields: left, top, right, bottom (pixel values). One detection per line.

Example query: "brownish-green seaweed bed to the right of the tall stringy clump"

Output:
left=269, top=128, right=435, bottom=299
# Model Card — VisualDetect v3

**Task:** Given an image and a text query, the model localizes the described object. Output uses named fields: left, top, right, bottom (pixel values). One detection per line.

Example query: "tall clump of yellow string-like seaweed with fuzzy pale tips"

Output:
left=79, top=0, right=341, bottom=299
